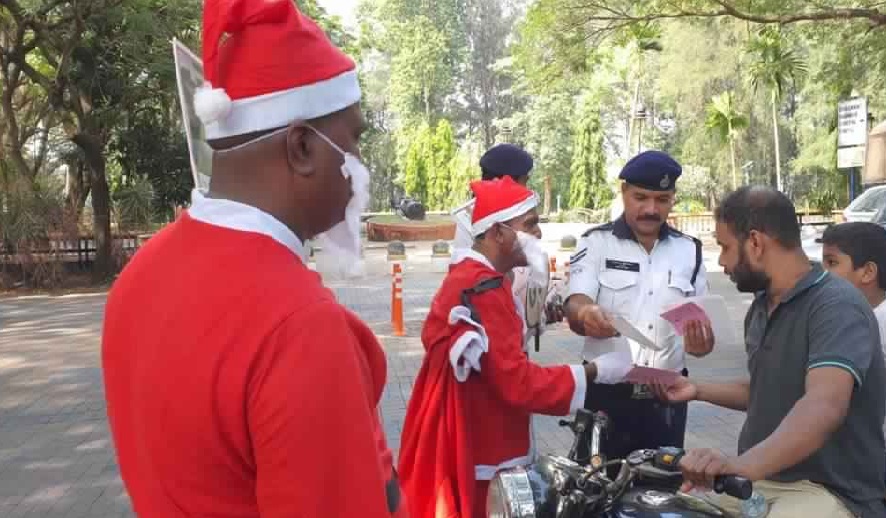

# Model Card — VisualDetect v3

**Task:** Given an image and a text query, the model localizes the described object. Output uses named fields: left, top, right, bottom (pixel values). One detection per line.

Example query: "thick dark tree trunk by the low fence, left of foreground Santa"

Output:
left=73, top=133, right=113, bottom=279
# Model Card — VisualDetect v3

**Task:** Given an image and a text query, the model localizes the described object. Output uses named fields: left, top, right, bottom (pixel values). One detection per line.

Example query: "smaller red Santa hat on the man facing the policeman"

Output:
left=471, top=176, right=538, bottom=237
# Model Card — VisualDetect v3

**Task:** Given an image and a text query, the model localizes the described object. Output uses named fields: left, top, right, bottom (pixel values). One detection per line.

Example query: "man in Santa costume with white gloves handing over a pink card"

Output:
left=399, top=177, right=631, bottom=518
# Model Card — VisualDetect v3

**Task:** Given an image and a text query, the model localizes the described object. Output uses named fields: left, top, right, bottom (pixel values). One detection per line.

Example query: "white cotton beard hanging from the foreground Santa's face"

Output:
left=317, top=154, right=370, bottom=278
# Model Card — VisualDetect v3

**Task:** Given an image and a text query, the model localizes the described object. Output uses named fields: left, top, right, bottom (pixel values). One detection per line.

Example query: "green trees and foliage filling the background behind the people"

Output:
left=0, top=0, right=886, bottom=284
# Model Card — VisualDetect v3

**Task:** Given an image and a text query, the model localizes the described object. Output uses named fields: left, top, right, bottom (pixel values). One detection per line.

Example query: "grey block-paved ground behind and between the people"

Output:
left=0, top=251, right=749, bottom=518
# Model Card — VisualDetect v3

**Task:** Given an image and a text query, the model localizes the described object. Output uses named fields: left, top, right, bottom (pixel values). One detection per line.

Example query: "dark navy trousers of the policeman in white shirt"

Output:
left=578, top=371, right=688, bottom=461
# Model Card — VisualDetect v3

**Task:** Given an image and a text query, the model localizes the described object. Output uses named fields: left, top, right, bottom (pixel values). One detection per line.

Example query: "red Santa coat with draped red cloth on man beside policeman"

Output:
left=399, top=252, right=586, bottom=518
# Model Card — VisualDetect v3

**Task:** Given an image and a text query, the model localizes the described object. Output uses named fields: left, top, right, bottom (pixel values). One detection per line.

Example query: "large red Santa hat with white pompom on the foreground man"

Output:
left=194, top=0, right=360, bottom=140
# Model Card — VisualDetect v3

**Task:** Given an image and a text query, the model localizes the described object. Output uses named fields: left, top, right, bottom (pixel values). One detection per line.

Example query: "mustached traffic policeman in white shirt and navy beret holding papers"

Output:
left=566, top=151, right=714, bottom=459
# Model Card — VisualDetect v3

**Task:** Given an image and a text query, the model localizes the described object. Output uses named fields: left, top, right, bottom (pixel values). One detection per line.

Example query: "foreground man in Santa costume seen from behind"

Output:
left=102, top=0, right=405, bottom=518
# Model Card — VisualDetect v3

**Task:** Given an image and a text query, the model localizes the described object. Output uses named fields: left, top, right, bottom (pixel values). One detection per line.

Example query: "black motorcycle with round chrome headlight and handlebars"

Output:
left=487, top=410, right=753, bottom=518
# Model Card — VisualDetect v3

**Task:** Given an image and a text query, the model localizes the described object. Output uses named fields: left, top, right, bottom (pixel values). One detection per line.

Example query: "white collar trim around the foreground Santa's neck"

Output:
left=188, top=189, right=307, bottom=262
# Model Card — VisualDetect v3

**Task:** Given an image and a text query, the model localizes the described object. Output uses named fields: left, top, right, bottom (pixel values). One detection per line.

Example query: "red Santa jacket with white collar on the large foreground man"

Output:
left=102, top=198, right=405, bottom=518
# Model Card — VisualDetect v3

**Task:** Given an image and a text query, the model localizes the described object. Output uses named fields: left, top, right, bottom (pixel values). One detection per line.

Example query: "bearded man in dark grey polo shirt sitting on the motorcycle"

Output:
left=658, top=187, right=886, bottom=518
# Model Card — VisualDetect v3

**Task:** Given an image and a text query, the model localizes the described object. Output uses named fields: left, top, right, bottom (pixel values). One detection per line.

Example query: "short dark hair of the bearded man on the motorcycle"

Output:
left=714, top=186, right=802, bottom=249
